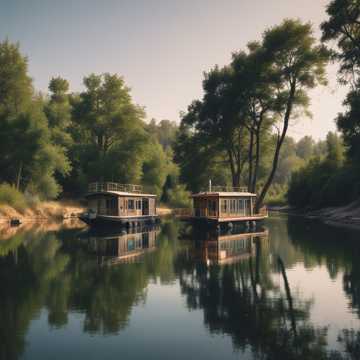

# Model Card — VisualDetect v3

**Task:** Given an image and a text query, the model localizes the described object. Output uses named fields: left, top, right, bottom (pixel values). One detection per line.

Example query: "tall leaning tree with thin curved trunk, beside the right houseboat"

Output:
left=256, top=20, right=329, bottom=208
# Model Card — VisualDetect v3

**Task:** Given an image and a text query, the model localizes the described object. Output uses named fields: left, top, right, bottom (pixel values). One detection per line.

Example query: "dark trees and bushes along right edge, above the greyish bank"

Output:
left=288, top=0, right=360, bottom=208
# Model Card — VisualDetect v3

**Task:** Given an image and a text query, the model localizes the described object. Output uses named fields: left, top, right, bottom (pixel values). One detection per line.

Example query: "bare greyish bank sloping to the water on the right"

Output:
left=270, top=199, right=360, bottom=230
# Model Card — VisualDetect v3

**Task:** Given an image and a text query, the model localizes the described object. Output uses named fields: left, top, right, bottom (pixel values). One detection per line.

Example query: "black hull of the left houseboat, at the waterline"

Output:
left=79, top=214, right=160, bottom=228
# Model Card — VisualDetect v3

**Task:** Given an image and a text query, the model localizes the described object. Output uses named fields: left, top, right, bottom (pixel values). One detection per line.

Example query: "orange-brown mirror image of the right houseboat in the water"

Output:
left=188, top=227, right=268, bottom=265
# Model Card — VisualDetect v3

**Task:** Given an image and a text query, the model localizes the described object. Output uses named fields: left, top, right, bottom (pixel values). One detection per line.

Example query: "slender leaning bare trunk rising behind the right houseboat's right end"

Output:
left=255, top=82, right=296, bottom=211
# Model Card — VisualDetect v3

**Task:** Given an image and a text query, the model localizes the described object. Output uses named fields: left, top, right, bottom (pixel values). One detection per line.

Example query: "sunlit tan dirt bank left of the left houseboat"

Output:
left=0, top=201, right=84, bottom=223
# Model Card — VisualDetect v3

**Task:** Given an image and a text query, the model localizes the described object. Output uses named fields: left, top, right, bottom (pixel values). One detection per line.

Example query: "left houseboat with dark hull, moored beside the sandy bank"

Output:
left=80, top=182, right=158, bottom=227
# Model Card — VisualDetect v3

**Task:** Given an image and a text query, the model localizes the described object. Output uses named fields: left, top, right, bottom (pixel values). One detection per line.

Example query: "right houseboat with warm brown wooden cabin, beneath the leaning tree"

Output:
left=182, top=185, right=268, bottom=227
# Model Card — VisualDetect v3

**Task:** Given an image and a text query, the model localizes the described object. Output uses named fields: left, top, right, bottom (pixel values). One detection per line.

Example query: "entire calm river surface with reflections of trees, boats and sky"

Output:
left=0, top=216, right=360, bottom=360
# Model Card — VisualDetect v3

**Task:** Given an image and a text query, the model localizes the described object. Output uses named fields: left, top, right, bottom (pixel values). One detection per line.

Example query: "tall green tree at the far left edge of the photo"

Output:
left=0, top=41, right=70, bottom=198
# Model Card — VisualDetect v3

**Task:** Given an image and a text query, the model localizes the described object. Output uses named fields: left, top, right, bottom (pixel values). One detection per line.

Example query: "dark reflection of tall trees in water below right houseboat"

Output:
left=177, top=226, right=334, bottom=359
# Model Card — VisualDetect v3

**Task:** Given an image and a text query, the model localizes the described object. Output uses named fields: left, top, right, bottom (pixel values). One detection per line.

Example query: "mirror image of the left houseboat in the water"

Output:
left=81, top=226, right=159, bottom=265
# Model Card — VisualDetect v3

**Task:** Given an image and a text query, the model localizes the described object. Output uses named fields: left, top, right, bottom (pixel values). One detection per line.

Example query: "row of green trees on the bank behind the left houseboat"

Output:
left=0, top=41, right=187, bottom=207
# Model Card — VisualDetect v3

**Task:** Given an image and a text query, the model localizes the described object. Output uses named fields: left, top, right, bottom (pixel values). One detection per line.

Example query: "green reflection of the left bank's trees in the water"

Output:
left=0, top=222, right=183, bottom=360
